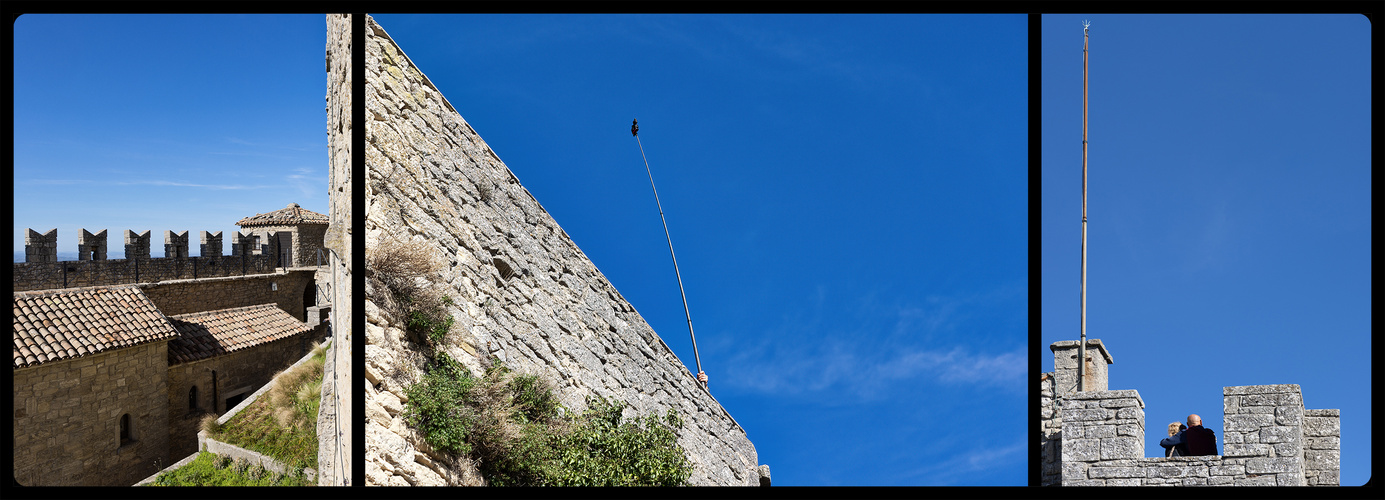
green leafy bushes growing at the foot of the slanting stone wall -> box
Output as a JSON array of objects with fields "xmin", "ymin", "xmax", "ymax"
[{"xmin": 406, "ymin": 353, "xmax": 693, "ymax": 486}]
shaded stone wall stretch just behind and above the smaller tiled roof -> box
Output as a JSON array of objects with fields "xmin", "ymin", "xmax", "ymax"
[{"xmin": 139, "ymin": 270, "xmax": 316, "ymax": 323}]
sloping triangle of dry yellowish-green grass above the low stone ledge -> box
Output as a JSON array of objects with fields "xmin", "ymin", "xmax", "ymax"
[{"xmin": 205, "ymin": 343, "xmax": 327, "ymax": 468}]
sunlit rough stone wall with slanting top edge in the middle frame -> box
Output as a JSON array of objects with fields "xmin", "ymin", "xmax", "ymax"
[{"xmin": 364, "ymin": 18, "xmax": 762, "ymax": 486}]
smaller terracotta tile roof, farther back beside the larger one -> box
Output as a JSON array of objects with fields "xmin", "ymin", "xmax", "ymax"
[{"xmin": 169, "ymin": 303, "xmax": 312, "ymax": 364}]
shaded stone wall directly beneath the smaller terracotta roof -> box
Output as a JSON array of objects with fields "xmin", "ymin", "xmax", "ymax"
[{"xmin": 168, "ymin": 325, "xmax": 327, "ymax": 460}]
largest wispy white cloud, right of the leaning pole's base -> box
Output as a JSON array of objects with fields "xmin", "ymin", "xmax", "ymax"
[{"xmin": 712, "ymin": 283, "xmax": 1028, "ymax": 400}]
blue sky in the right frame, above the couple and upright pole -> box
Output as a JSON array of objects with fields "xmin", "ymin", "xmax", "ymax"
[{"xmin": 1040, "ymin": 14, "xmax": 1371, "ymax": 485}]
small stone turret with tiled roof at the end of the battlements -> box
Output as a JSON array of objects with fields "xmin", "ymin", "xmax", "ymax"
[{"xmin": 235, "ymin": 204, "xmax": 328, "ymax": 267}]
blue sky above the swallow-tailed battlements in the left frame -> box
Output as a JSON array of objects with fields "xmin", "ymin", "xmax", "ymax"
[{"xmin": 12, "ymin": 14, "xmax": 327, "ymax": 262}]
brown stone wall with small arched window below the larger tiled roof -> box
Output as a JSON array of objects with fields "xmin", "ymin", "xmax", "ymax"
[{"xmin": 14, "ymin": 341, "xmax": 170, "ymax": 486}]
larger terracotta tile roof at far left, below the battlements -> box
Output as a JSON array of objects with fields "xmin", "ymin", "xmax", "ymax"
[{"xmin": 14, "ymin": 287, "xmax": 177, "ymax": 368}]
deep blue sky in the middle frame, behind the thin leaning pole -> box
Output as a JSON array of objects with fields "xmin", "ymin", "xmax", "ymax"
[{"xmin": 375, "ymin": 14, "xmax": 1030, "ymax": 485}]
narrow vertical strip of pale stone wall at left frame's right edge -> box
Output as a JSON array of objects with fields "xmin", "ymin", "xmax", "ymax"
[{"xmin": 317, "ymin": 14, "xmax": 360, "ymax": 486}]
